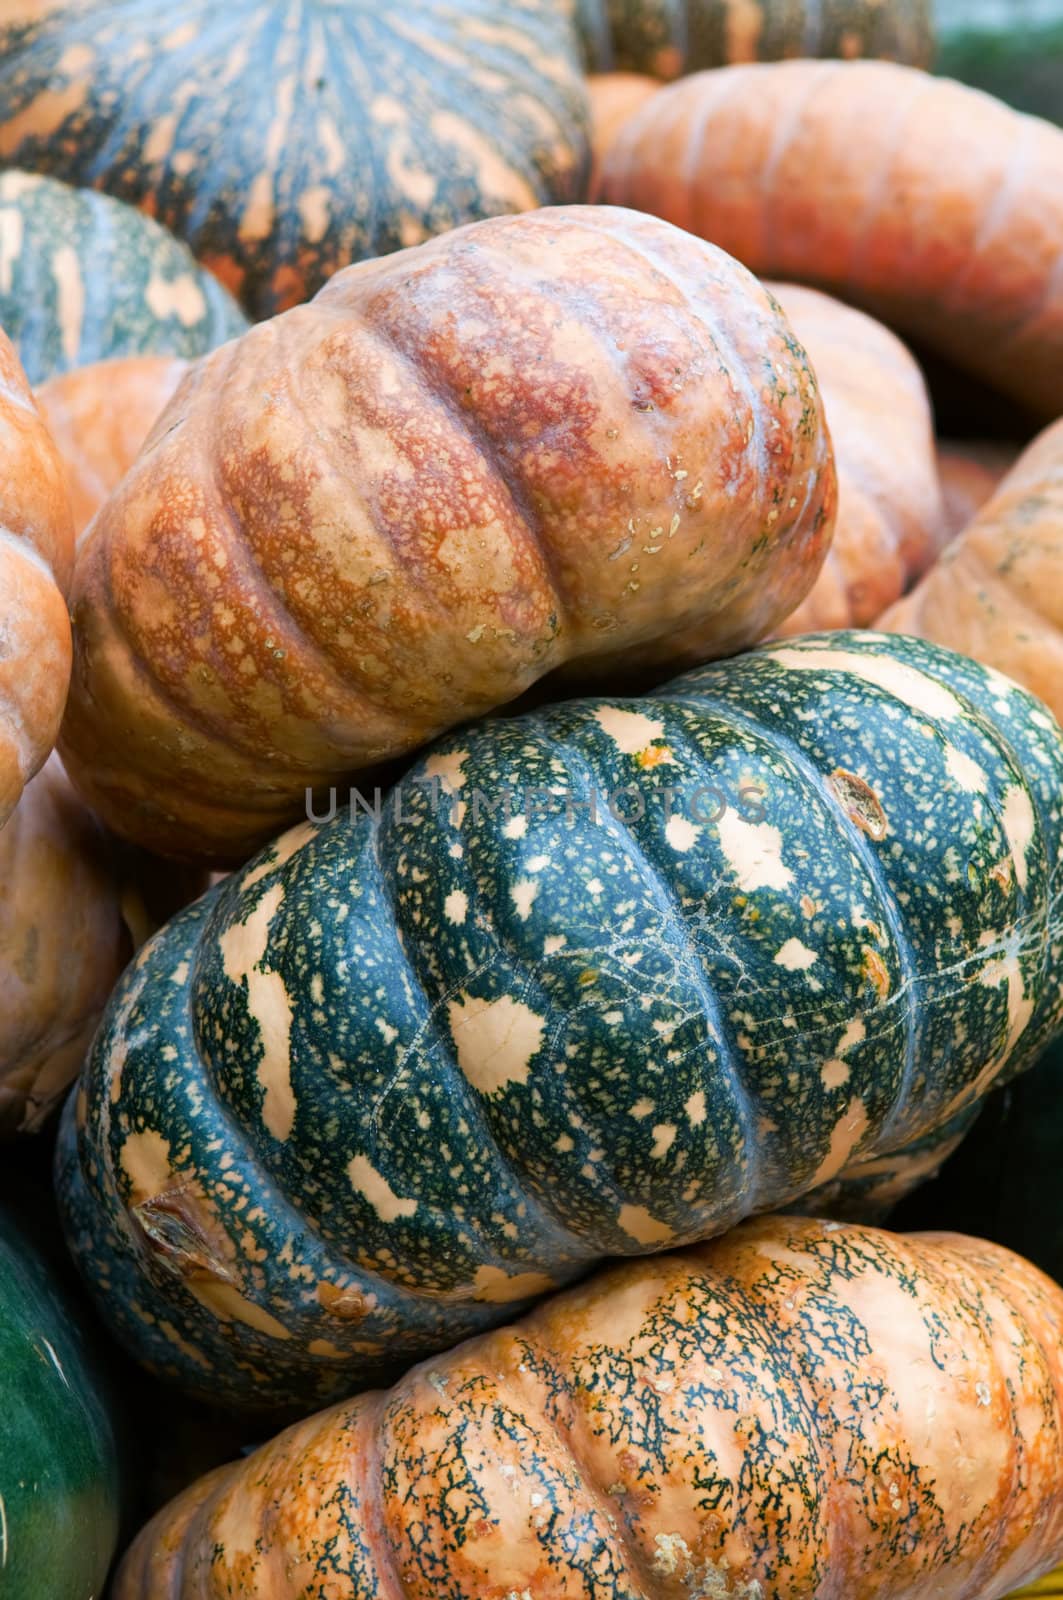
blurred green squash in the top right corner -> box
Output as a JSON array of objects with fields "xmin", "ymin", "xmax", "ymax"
[{"xmin": 933, "ymin": 0, "xmax": 1063, "ymax": 123}]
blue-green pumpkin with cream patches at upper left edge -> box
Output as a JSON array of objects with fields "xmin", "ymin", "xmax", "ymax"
[{"xmin": 0, "ymin": 173, "xmax": 247, "ymax": 384}]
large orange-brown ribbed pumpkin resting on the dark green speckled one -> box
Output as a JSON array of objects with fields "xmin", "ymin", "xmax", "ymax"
[{"xmin": 62, "ymin": 208, "xmax": 834, "ymax": 864}]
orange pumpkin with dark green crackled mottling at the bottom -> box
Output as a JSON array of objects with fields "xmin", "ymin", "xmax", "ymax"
[{"xmin": 115, "ymin": 1218, "xmax": 1063, "ymax": 1600}]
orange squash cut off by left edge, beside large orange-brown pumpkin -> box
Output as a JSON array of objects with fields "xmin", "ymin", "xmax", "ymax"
[{"xmin": 0, "ymin": 324, "xmax": 74, "ymax": 827}]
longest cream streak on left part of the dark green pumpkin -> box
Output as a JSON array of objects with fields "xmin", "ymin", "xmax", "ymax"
[{"xmin": 218, "ymin": 883, "xmax": 296, "ymax": 1141}]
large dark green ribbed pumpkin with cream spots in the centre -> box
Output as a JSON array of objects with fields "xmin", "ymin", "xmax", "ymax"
[{"xmin": 59, "ymin": 634, "xmax": 1063, "ymax": 1406}]
